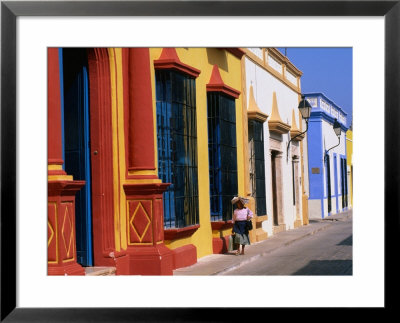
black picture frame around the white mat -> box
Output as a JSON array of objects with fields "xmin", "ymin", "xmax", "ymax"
[{"xmin": 0, "ymin": 0, "xmax": 400, "ymax": 322}]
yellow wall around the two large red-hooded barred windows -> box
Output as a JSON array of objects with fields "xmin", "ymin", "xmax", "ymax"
[{"xmin": 150, "ymin": 48, "xmax": 245, "ymax": 258}]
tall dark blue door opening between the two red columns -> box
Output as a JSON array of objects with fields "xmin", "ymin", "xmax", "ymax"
[{"xmin": 62, "ymin": 48, "xmax": 93, "ymax": 266}]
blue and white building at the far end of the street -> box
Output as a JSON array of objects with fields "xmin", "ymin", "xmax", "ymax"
[{"xmin": 305, "ymin": 93, "xmax": 349, "ymax": 219}]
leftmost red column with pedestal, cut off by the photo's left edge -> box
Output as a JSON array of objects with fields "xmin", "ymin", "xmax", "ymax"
[{"xmin": 47, "ymin": 48, "xmax": 85, "ymax": 275}]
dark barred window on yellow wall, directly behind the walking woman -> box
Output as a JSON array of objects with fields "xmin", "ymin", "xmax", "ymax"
[{"xmin": 207, "ymin": 92, "xmax": 238, "ymax": 221}]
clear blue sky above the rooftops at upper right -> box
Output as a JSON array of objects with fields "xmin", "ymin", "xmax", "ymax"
[{"xmin": 278, "ymin": 47, "xmax": 353, "ymax": 126}]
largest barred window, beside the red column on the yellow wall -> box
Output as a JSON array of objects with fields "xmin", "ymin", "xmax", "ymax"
[{"xmin": 156, "ymin": 70, "xmax": 199, "ymax": 228}]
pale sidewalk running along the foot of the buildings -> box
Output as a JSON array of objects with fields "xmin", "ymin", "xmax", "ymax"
[{"xmin": 173, "ymin": 210, "xmax": 353, "ymax": 276}]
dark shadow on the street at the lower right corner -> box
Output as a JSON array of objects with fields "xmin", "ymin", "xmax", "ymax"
[{"xmin": 293, "ymin": 260, "xmax": 353, "ymax": 276}]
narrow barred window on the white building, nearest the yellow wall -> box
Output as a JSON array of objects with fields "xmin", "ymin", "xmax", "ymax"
[{"xmin": 249, "ymin": 120, "xmax": 267, "ymax": 216}]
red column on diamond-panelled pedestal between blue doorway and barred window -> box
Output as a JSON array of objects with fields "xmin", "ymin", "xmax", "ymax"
[{"xmin": 124, "ymin": 48, "xmax": 173, "ymax": 275}]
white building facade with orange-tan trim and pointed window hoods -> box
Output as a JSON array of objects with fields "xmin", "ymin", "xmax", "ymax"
[{"xmin": 242, "ymin": 48, "xmax": 308, "ymax": 240}]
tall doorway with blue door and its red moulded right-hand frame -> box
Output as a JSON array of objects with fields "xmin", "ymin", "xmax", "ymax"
[{"xmin": 60, "ymin": 48, "xmax": 115, "ymax": 266}]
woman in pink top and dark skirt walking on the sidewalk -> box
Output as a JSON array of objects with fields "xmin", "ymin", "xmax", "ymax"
[{"xmin": 231, "ymin": 196, "xmax": 253, "ymax": 256}]
